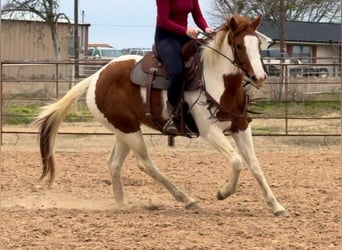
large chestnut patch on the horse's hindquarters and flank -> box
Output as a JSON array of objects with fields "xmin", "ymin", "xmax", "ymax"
[{"xmin": 95, "ymin": 60, "xmax": 166, "ymax": 133}]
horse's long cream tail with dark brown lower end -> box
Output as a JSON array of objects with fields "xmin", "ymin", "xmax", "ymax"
[{"xmin": 33, "ymin": 76, "xmax": 92, "ymax": 186}]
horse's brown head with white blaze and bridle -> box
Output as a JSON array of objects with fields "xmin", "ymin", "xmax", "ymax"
[{"xmin": 225, "ymin": 15, "xmax": 266, "ymax": 88}]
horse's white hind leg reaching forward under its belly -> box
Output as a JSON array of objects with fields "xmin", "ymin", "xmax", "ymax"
[{"xmin": 116, "ymin": 131, "xmax": 197, "ymax": 209}]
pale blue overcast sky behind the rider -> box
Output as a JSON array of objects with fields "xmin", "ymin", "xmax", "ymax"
[{"xmin": 59, "ymin": 0, "xmax": 212, "ymax": 49}]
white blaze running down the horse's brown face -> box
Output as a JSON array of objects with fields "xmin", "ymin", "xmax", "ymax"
[{"xmin": 244, "ymin": 36, "xmax": 266, "ymax": 80}]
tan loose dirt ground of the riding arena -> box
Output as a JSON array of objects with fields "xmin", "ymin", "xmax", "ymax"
[{"xmin": 0, "ymin": 130, "xmax": 342, "ymax": 249}]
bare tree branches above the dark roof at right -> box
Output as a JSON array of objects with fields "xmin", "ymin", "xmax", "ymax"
[{"xmin": 211, "ymin": 0, "xmax": 341, "ymax": 23}]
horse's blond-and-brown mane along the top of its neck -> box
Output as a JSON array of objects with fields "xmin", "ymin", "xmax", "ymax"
[{"xmin": 202, "ymin": 14, "xmax": 250, "ymax": 61}]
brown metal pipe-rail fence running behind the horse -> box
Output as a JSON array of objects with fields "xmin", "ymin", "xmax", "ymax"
[{"xmin": 0, "ymin": 60, "xmax": 341, "ymax": 140}]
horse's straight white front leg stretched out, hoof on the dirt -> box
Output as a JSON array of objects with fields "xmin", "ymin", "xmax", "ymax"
[{"xmin": 232, "ymin": 127, "xmax": 287, "ymax": 216}]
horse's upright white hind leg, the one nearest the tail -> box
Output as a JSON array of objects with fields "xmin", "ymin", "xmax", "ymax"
[{"xmin": 108, "ymin": 140, "xmax": 130, "ymax": 207}]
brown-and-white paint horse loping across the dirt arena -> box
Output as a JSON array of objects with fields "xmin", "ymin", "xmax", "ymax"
[{"xmin": 35, "ymin": 15, "xmax": 287, "ymax": 216}]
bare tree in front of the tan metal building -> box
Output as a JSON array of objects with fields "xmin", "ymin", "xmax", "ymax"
[{"xmin": 2, "ymin": 0, "xmax": 70, "ymax": 60}]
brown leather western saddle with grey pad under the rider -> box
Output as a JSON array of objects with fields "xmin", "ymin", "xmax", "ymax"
[{"xmin": 130, "ymin": 40, "xmax": 202, "ymax": 137}]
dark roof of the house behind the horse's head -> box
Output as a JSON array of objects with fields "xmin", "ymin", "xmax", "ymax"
[{"xmin": 258, "ymin": 20, "xmax": 341, "ymax": 43}]
